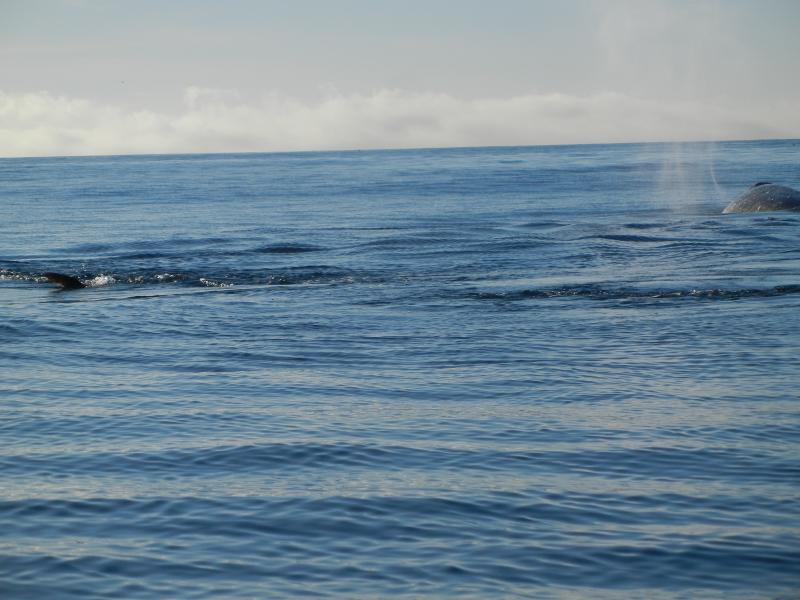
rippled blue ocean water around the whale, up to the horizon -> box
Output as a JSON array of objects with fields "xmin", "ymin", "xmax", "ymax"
[{"xmin": 0, "ymin": 140, "xmax": 800, "ymax": 599}]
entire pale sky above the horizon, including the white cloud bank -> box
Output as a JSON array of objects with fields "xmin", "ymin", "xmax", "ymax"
[{"xmin": 0, "ymin": 0, "xmax": 800, "ymax": 157}]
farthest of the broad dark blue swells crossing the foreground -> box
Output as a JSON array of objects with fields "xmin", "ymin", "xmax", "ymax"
[{"xmin": 0, "ymin": 443, "xmax": 800, "ymax": 484}]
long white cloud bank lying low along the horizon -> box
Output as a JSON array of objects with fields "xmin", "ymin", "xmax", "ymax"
[{"xmin": 0, "ymin": 87, "xmax": 800, "ymax": 157}]
